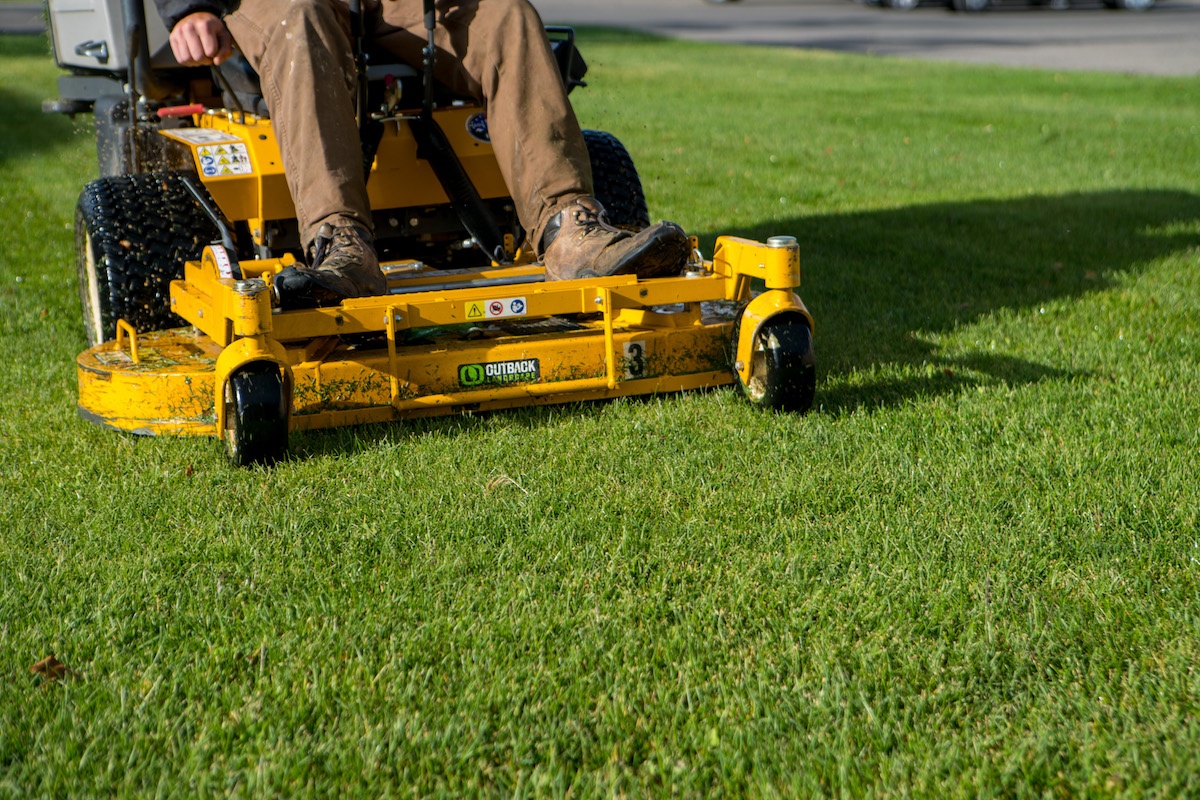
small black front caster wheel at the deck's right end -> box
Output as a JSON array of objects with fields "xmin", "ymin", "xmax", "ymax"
[{"xmin": 734, "ymin": 314, "xmax": 817, "ymax": 413}]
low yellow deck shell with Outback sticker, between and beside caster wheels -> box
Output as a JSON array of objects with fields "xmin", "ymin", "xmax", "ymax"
[{"xmin": 78, "ymin": 323, "xmax": 734, "ymax": 435}]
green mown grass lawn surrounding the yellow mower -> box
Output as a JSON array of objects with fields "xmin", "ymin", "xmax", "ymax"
[{"xmin": 0, "ymin": 30, "xmax": 1200, "ymax": 798}]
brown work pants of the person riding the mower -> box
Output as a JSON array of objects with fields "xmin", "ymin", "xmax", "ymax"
[{"xmin": 226, "ymin": 0, "xmax": 592, "ymax": 246}]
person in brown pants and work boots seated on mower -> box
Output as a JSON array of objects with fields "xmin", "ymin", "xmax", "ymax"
[{"xmin": 156, "ymin": 0, "xmax": 690, "ymax": 308}]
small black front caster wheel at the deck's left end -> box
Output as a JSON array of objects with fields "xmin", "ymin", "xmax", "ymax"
[{"xmin": 224, "ymin": 361, "xmax": 288, "ymax": 467}]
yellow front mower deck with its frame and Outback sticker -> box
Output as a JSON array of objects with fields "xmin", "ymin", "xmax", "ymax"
[{"xmin": 78, "ymin": 237, "xmax": 812, "ymax": 461}]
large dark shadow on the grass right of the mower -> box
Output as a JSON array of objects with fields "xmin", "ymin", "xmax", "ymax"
[{"xmin": 720, "ymin": 190, "xmax": 1200, "ymax": 414}]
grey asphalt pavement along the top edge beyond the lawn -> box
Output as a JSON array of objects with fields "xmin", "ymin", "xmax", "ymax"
[{"xmin": 9, "ymin": 0, "xmax": 1200, "ymax": 76}]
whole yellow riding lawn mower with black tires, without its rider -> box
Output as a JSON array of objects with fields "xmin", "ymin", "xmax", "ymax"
[{"xmin": 46, "ymin": 0, "xmax": 816, "ymax": 465}]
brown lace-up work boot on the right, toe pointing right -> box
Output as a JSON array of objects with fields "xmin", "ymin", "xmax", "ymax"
[{"xmin": 541, "ymin": 197, "xmax": 691, "ymax": 281}]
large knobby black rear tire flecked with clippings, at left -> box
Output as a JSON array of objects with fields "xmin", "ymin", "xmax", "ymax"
[{"xmin": 76, "ymin": 173, "xmax": 217, "ymax": 345}]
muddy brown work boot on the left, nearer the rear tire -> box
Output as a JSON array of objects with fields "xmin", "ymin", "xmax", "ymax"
[{"xmin": 271, "ymin": 218, "xmax": 388, "ymax": 311}]
